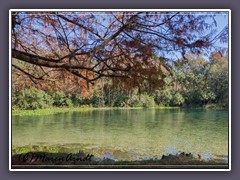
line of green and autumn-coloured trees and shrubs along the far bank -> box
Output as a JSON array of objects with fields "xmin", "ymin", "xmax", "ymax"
[{"xmin": 12, "ymin": 52, "xmax": 228, "ymax": 109}]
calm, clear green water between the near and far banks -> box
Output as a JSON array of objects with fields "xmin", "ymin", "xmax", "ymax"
[{"xmin": 12, "ymin": 109, "xmax": 228, "ymax": 160}]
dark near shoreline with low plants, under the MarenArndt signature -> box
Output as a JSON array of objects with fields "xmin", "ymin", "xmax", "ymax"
[{"xmin": 11, "ymin": 146, "xmax": 228, "ymax": 168}]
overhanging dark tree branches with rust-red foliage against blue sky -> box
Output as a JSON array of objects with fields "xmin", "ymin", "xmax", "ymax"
[{"xmin": 12, "ymin": 12, "xmax": 227, "ymax": 91}]
